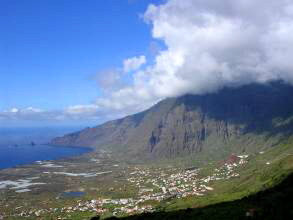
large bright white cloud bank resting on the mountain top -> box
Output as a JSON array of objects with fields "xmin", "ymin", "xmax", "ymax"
[{"xmin": 3, "ymin": 0, "xmax": 293, "ymax": 124}]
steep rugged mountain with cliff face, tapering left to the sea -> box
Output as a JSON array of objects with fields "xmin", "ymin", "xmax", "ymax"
[{"xmin": 52, "ymin": 82, "xmax": 293, "ymax": 159}]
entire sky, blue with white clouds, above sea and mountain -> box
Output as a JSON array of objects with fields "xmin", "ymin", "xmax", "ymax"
[{"xmin": 0, "ymin": 0, "xmax": 293, "ymax": 126}]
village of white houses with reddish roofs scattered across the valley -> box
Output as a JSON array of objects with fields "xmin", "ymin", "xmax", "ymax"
[{"xmin": 8, "ymin": 155, "xmax": 248, "ymax": 219}]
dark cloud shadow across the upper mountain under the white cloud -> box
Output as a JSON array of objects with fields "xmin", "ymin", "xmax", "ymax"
[{"xmin": 176, "ymin": 81, "xmax": 293, "ymax": 135}]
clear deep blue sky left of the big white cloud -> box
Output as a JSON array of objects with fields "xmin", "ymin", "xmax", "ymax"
[{"xmin": 0, "ymin": 0, "xmax": 160, "ymax": 110}]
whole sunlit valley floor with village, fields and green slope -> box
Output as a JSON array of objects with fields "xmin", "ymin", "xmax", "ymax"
[{"xmin": 0, "ymin": 144, "xmax": 293, "ymax": 219}]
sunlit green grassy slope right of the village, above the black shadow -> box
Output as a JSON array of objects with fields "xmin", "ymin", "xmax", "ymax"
[{"xmin": 164, "ymin": 139, "xmax": 293, "ymax": 211}]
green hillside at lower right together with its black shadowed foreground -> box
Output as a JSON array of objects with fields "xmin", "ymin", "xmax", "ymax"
[{"xmin": 99, "ymin": 143, "xmax": 293, "ymax": 220}]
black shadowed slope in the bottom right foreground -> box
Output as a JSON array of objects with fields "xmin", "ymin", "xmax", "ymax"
[{"xmin": 92, "ymin": 173, "xmax": 293, "ymax": 220}]
